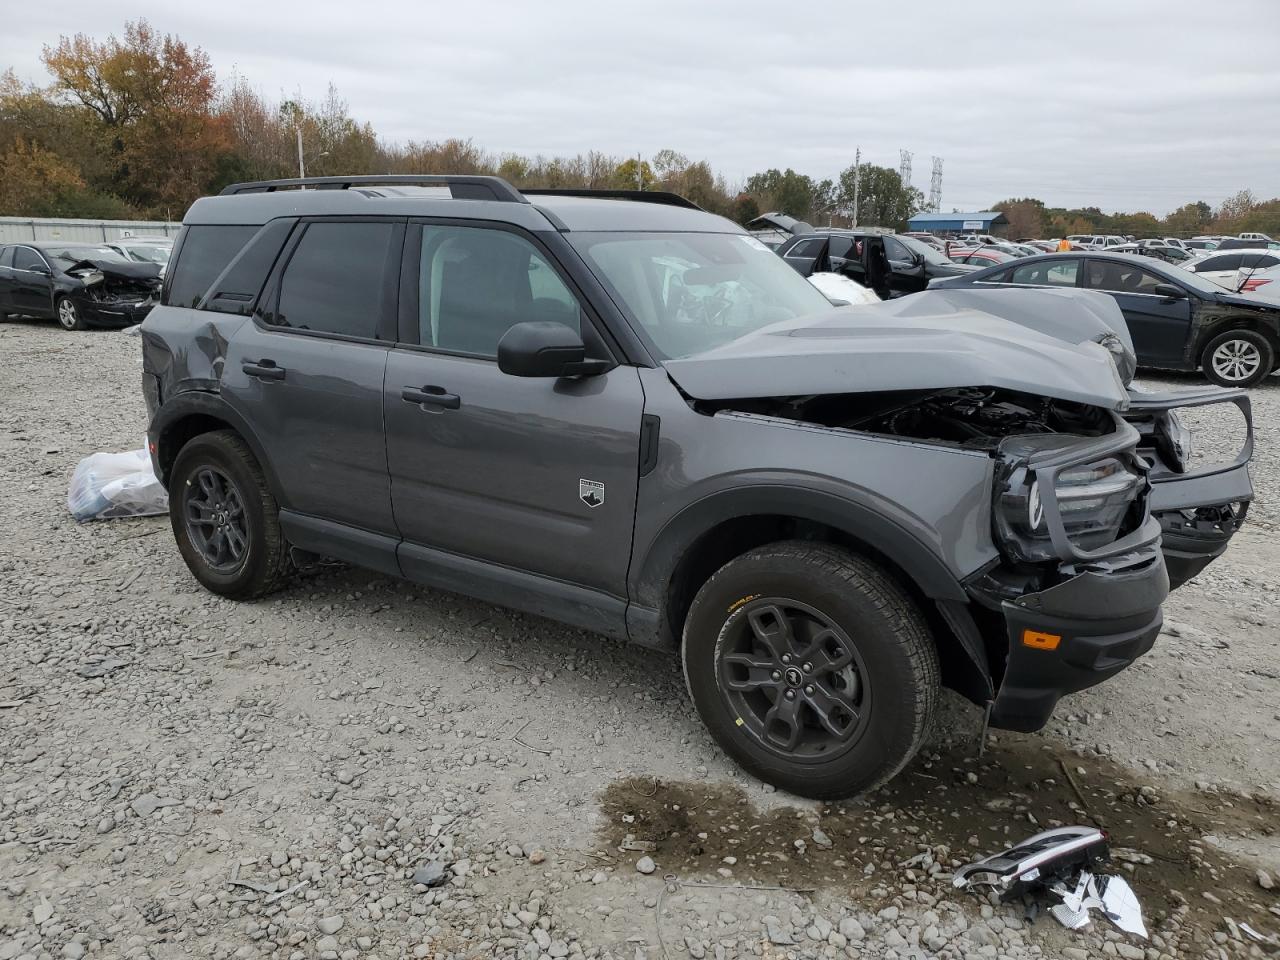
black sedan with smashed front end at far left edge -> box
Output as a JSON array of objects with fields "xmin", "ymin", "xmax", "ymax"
[{"xmin": 0, "ymin": 241, "xmax": 160, "ymax": 330}]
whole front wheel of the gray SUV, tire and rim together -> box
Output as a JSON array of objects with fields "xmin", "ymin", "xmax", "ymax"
[{"xmin": 682, "ymin": 540, "xmax": 940, "ymax": 800}]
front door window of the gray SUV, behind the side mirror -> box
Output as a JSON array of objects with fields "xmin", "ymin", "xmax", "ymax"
[{"xmin": 417, "ymin": 224, "xmax": 582, "ymax": 360}]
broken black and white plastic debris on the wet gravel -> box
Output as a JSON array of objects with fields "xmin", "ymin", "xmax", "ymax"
[{"xmin": 951, "ymin": 827, "xmax": 1147, "ymax": 940}]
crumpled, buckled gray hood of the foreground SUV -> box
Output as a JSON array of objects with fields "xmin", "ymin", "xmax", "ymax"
[{"xmin": 664, "ymin": 291, "xmax": 1129, "ymax": 411}]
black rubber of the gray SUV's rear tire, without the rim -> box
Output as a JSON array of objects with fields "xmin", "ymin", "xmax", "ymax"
[{"xmin": 169, "ymin": 435, "xmax": 269, "ymax": 596}]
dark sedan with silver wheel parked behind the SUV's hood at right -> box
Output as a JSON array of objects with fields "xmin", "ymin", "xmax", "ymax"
[{"xmin": 931, "ymin": 251, "xmax": 1280, "ymax": 387}]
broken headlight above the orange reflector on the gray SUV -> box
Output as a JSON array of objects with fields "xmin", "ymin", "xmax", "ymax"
[{"xmin": 996, "ymin": 457, "xmax": 1144, "ymax": 561}]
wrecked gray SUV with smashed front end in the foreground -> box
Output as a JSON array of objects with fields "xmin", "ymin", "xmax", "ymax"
[{"xmin": 142, "ymin": 177, "xmax": 1252, "ymax": 797}]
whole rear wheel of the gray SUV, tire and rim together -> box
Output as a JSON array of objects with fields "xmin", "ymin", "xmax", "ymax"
[{"xmin": 169, "ymin": 430, "xmax": 289, "ymax": 600}]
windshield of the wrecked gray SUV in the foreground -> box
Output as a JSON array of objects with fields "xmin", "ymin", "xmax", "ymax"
[{"xmin": 566, "ymin": 233, "xmax": 831, "ymax": 360}]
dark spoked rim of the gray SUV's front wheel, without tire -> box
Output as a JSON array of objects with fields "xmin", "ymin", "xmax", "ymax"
[{"xmin": 716, "ymin": 596, "xmax": 872, "ymax": 760}]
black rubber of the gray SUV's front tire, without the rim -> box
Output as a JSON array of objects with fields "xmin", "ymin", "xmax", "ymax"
[{"xmin": 682, "ymin": 556, "xmax": 925, "ymax": 797}]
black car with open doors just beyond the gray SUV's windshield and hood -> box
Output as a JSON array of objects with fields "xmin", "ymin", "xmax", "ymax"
[{"xmin": 776, "ymin": 229, "xmax": 975, "ymax": 300}]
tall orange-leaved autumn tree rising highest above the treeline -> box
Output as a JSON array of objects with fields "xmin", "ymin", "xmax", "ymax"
[{"xmin": 42, "ymin": 20, "xmax": 229, "ymax": 215}]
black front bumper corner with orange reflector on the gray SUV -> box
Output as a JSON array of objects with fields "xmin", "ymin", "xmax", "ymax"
[{"xmin": 991, "ymin": 550, "xmax": 1169, "ymax": 732}]
